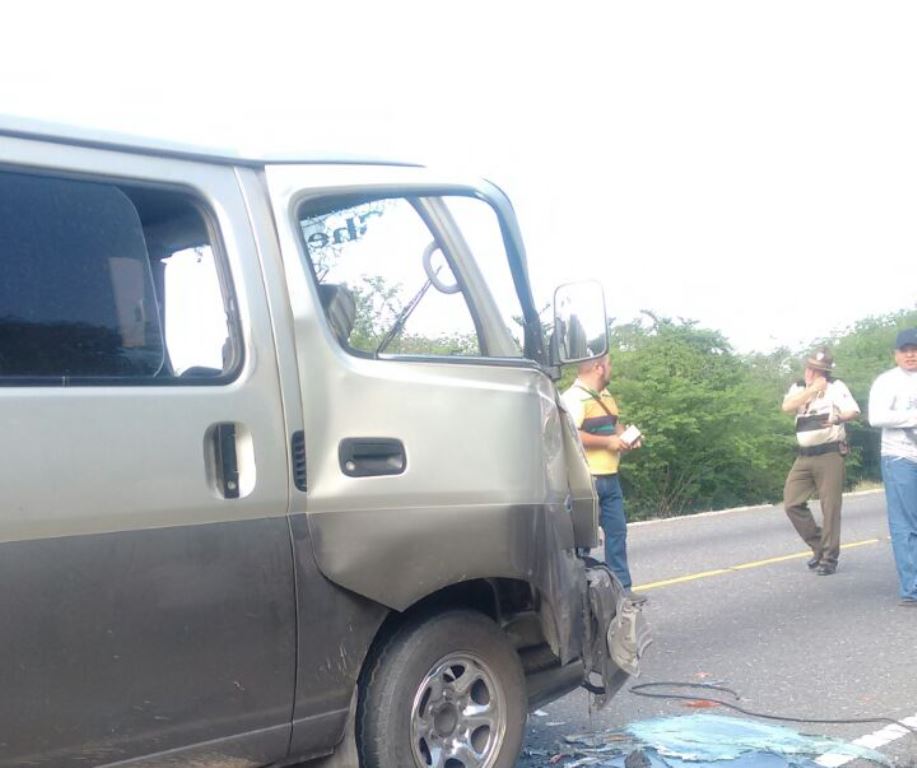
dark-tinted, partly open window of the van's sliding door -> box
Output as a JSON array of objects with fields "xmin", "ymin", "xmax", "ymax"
[{"xmin": 0, "ymin": 171, "xmax": 238, "ymax": 386}]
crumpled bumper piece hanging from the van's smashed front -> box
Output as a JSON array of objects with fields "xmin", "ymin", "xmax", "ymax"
[{"xmin": 584, "ymin": 563, "xmax": 653, "ymax": 709}]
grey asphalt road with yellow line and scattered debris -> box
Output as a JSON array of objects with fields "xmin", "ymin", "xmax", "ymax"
[{"xmin": 519, "ymin": 492, "xmax": 917, "ymax": 768}]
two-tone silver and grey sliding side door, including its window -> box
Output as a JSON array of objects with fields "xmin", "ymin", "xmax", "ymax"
[{"xmin": 0, "ymin": 146, "xmax": 295, "ymax": 768}]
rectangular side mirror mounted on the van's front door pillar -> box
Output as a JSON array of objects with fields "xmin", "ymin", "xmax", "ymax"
[{"xmin": 551, "ymin": 280, "xmax": 608, "ymax": 365}]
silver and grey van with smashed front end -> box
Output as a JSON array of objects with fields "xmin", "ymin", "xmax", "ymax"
[{"xmin": 0, "ymin": 119, "xmax": 648, "ymax": 768}]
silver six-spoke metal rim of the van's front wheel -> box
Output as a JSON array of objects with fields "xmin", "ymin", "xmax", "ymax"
[{"xmin": 411, "ymin": 653, "xmax": 506, "ymax": 768}]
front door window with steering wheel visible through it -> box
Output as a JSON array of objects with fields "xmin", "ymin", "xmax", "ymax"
[{"xmin": 299, "ymin": 197, "xmax": 521, "ymax": 357}]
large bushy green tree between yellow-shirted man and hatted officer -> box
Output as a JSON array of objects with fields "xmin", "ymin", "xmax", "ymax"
[{"xmin": 611, "ymin": 319, "xmax": 790, "ymax": 516}]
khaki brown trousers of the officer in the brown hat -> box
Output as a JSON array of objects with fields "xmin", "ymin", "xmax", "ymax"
[{"xmin": 783, "ymin": 452, "xmax": 844, "ymax": 565}]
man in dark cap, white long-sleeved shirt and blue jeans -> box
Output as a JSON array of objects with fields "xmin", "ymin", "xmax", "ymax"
[{"xmin": 869, "ymin": 328, "xmax": 917, "ymax": 608}]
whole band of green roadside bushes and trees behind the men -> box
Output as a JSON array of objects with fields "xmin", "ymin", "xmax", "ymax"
[{"xmin": 561, "ymin": 308, "xmax": 917, "ymax": 520}]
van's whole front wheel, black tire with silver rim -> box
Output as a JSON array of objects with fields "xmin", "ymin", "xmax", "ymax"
[{"xmin": 357, "ymin": 611, "xmax": 527, "ymax": 768}]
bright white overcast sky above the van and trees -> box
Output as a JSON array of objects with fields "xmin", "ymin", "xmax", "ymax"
[{"xmin": 0, "ymin": 0, "xmax": 917, "ymax": 352}]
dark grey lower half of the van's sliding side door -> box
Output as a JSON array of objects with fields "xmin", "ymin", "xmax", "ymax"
[{"xmin": 0, "ymin": 517, "xmax": 295, "ymax": 768}]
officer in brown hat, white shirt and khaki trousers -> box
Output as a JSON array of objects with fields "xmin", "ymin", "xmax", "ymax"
[{"xmin": 783, "ymin": 349, "xmax": 860, "ymax": 576}]
